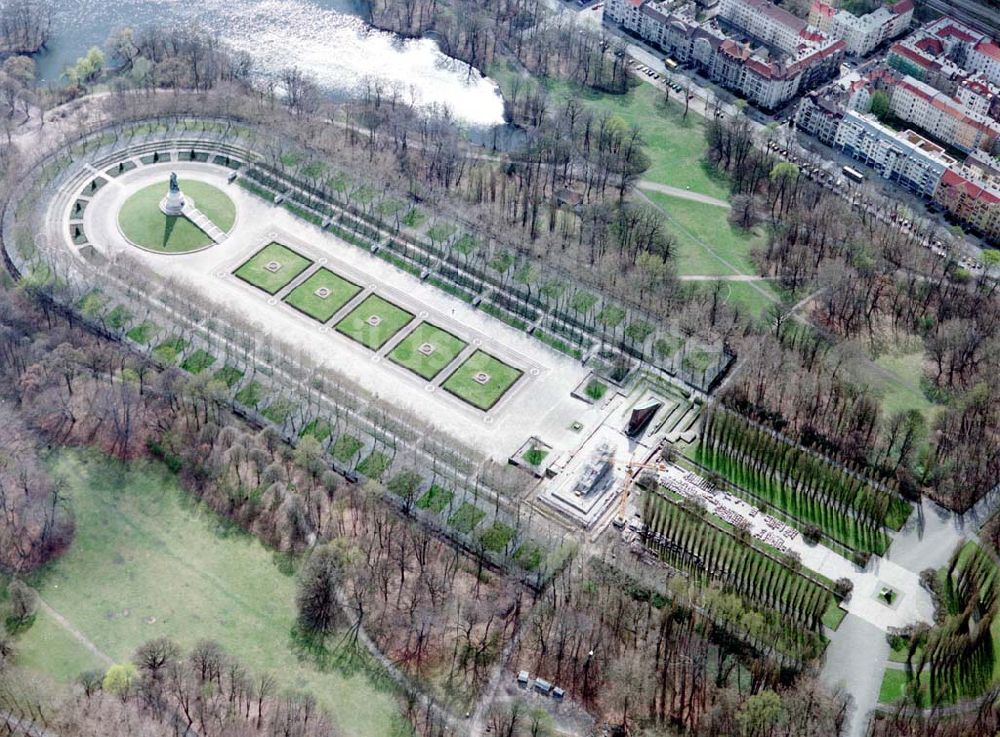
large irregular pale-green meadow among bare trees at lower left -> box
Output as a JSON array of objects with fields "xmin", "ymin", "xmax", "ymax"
[{"xmin": 19, "ymin": 451, "xmax": 405, "ymax": 737}]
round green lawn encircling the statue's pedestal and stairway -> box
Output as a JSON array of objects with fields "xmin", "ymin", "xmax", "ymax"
[{"xmin": 118, "ymin": 180, "xmax": 236, "ymax": 253}]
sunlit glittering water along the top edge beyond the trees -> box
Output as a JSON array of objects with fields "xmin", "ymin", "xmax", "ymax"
[{"xmin": 38, "ymin": 0, "xmax": 503, "ymax": 126}]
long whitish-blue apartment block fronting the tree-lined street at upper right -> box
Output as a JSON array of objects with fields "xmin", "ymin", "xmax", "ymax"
[{"xmin": 834, "ymin": 110, "xmax": 957, "ymax": 197}]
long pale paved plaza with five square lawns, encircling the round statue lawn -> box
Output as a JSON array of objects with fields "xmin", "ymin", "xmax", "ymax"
[{"xmin": 74, "ymin": 161, "xmax": 604, "ymax": 462}]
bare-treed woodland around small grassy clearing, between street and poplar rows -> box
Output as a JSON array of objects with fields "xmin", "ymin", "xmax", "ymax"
[{"xmin": 708, "ymin": 116, "xmax": 1000, "ymax": 509}]
